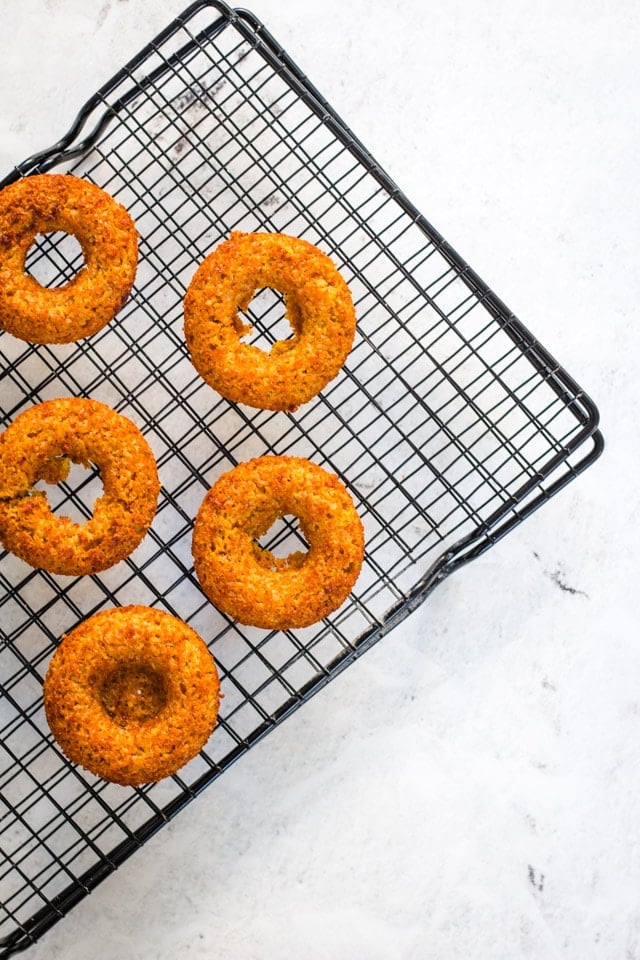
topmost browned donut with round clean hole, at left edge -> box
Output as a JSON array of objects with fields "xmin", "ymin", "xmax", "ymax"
[{"xmin": 0, "ymin": 173, "xmax": 138, "ymax": 343}]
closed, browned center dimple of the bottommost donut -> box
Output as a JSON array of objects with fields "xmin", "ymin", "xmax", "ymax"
[{"xmin": 99, "ymin": 663, "xmax": 167, "ymax": 727}]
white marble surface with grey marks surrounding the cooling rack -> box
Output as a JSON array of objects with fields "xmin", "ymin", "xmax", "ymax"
[{"xmin": 0, "ymin": 0, "xmax": 640, "ymax": 960}]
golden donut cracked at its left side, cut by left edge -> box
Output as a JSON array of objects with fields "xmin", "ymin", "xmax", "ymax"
[{"xmin": 0, "ymin": 397, "xmax": 160, "ymax": 576}]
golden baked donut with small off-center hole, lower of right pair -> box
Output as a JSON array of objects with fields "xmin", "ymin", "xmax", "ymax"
[{"xmin": 192, "ymin": 456, "xmax": 364, "ymax": 630}]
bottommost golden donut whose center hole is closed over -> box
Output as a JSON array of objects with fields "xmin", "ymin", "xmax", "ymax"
[{"xmin": 43, "ymin": 605, "xmax": 220, "ymax": 786}]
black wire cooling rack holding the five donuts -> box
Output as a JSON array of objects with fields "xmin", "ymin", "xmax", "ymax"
[{"xmin": 0, "ymin": 0, "xmax": 602, "ymax": 957}]
